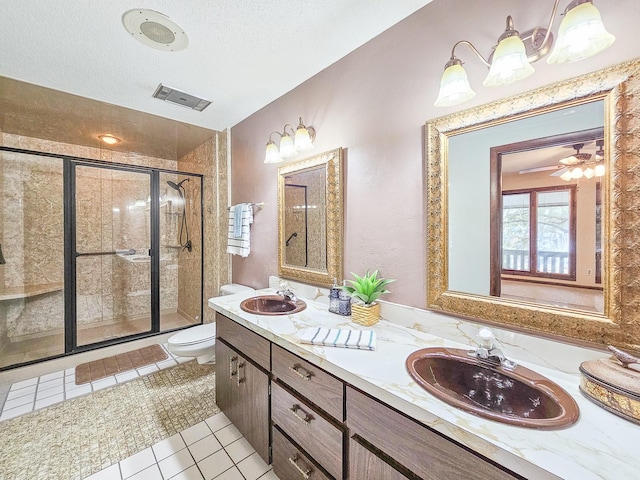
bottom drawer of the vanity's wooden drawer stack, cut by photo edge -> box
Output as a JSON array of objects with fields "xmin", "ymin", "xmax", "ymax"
[{"xmin": 272, "ymin": 428, "xmax": 329, "ymax": 480}]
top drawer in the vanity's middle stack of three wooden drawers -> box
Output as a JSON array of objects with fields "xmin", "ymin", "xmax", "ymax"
[{"xmin": 272, "ymin": 345, "xmax": 344, "ymax": 421}]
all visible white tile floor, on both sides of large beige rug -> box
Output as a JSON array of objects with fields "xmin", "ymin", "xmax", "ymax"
[{"xmin": 0, "ymin": 345, "xmax": 278, "ymax": 480}]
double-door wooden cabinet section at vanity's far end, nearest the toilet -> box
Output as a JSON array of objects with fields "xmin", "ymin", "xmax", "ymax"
[{"xmin": 216, "ymin": 314, "xmax": 270, "ymax": 463}]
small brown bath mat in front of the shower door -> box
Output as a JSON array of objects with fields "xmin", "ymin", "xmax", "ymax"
[{"xmin": 76, "ymin": 343, "xmax": 168, "ymax": 385}]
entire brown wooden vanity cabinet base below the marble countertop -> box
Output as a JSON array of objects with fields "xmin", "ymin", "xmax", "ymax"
[{"xmin": 216, "ymin": 313, "xmax": 523, "ymax": 480}]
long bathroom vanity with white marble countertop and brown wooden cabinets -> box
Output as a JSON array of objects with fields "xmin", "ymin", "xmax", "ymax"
[{"xmin": 209, "ymin": 289, "xmax": 640, "ymax": 480}]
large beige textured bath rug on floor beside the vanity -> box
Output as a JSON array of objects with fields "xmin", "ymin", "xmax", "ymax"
[{"xmin": 0, "ymin": 361, "xmax": 220, "ymax": 480}]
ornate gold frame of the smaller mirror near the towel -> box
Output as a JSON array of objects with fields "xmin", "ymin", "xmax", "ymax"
[{"xmin": 278, "ymin": 148, "xmax": 344, "ymax": 287}]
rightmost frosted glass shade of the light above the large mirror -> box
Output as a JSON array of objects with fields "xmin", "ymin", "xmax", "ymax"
[{"xmin": 547, "ymin": 2, "xmax": 616, "ymax": 63}]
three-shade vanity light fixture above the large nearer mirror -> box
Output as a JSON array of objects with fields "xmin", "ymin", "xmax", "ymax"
[{"xmin": 434, "ymin": 0, "xmax": 615, "ymax": 107}]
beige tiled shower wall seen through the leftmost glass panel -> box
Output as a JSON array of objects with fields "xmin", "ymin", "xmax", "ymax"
[{"xmin": 0, "ymin": 148, "xmax": 64, "ymax": 339}]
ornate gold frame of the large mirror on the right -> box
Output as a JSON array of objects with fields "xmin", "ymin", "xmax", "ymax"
[{"xmin": 424, "ymin": 59, "xmax": 640, "ymax": 352}]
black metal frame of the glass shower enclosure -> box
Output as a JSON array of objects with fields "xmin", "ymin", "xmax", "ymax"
[{"xmin": 0, "ymin": 145, "xmax": 206, "ymax": 371}]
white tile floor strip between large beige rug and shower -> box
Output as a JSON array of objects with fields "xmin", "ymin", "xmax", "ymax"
[{"xmin": 0, "ymin": 346, "xmax": 190, "ymax": 421}]
